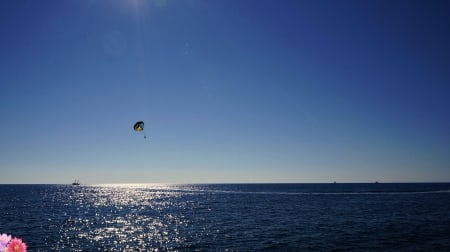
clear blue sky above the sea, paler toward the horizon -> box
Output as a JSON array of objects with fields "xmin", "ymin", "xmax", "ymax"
[{"xmin": 0, "ymin": 0, "xmax": 450, "ymax": 184}]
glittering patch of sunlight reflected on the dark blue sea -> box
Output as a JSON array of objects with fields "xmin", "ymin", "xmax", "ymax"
[{"xmin": 54, "ymin": 184, "xmax": 203, "ymax": 251}]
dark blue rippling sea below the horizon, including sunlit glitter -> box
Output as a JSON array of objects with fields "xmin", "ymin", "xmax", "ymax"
[{"xmin": 0, "ymin": 183, "xmax": 450, "ymax": 251}]
